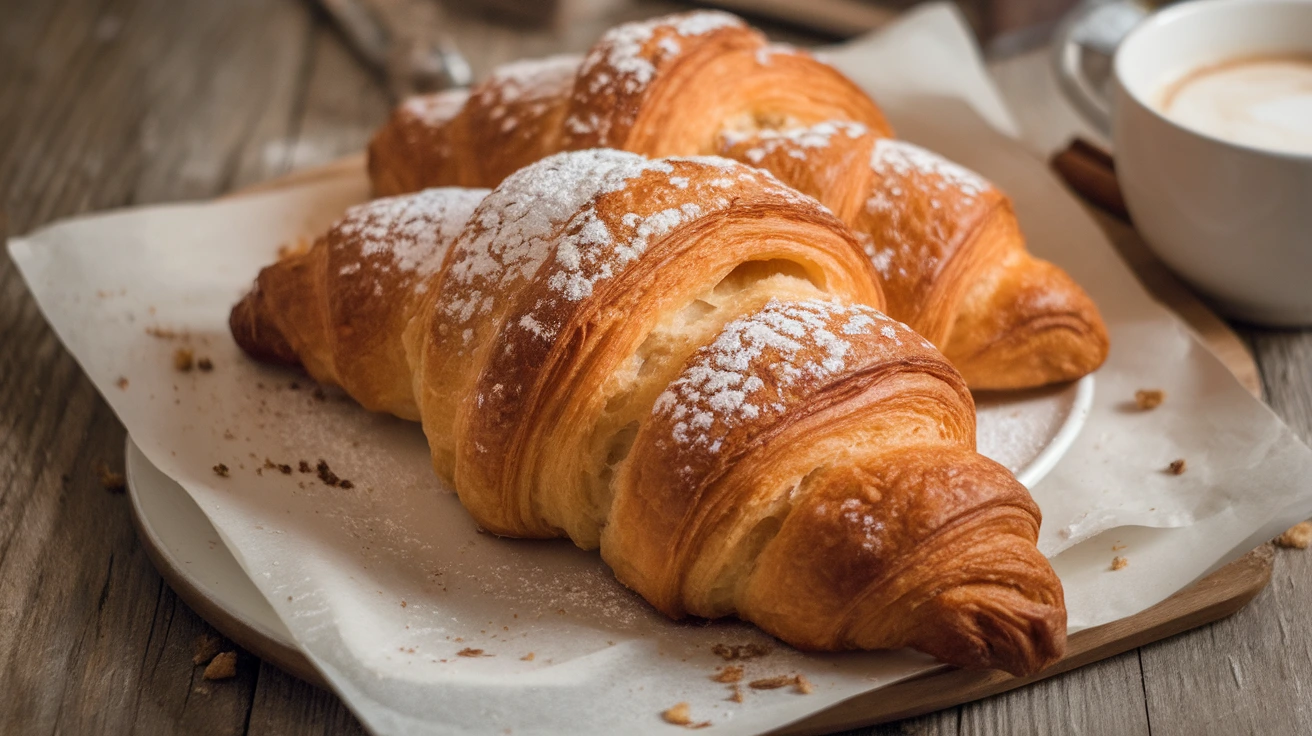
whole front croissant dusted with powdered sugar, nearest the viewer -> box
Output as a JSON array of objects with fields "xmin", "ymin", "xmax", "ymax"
[{"xmin": 231, "ymin": 150, "xmax": 1065, "ymax": 673}]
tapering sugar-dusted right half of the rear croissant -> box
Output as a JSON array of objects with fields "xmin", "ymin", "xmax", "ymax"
[{"xmin": 720, "ymin": 122, "xmax": 1109, "ymax": 388}]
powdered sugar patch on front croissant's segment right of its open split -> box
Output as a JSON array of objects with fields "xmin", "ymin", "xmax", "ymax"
[{"xmin": 652, "ymin": 299, "xmax": 913, "ymax": 453}]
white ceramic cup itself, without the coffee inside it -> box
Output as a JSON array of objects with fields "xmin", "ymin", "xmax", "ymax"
[{"xmin": 1068, "ymin": 0, "xmax": 1312, "ymax": 325}]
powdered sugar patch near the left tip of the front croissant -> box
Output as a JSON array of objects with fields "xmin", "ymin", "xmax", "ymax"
[{"xmin": 333, "ymin": 186, "xmax": 488, "ymax": 287}]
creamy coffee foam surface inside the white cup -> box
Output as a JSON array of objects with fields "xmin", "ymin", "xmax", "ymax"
[{"xmin": 1157, "ymin": 55, "xmax": 1312, "ymax": 153}]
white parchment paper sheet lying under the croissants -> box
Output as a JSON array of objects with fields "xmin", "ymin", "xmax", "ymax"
[{"xmin": 9, "ymin": 7, "xmax": 1312, "ymax": 733}]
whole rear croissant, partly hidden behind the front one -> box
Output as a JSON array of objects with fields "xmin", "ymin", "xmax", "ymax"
[{"xmin": 369, "ymin": 12, "xmax": 1109, "ymax": 388}]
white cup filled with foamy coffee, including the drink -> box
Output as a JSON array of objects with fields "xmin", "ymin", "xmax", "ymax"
[{"xmin": 1059, "ymin": 0, "xmax": 1312, "ymax": 325}]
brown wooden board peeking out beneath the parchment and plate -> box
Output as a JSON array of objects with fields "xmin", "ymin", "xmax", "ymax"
[{"xmin": 174, "ymin": 155, "xmax": 1274, "ymax": 735}]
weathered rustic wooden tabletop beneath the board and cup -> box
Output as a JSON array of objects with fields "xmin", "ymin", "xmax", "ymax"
[{"xmin": 0, "ymin": 0, "xmax": 1312, "ymax": 735}]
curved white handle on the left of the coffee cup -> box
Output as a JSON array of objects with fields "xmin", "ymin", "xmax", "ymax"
[{"xmin": 1052, "ymin": 0, "xmax": 1147, "ymax": 138}]
